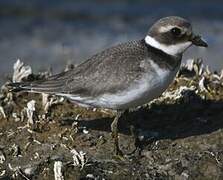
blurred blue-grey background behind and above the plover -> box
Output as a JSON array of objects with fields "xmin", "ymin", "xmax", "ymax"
[{"xmin": 0, "ymin": 0, "xmax": 223, "ymax": 82}]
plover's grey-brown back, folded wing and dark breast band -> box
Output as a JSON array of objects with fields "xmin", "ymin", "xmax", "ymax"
[{"xmin": 11, "ymin": 40, "xmax": 181, "ymax": 100}]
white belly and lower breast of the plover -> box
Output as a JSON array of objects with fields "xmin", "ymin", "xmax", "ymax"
[{"xmin": 71, "ymin": 62, "xmax": 179, "ymax": 109}]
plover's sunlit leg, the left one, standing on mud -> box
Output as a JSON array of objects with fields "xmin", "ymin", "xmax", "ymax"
[{"xmin": 111, "ymin": 111, "xmax": 123, "ymax": 156}]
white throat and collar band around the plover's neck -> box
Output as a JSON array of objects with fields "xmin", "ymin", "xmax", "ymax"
[{"xmin": 145, "ymin": 35, "xmax": 192, "ymax": 56}]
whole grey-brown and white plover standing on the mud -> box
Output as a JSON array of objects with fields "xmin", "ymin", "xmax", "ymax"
[{"xmin": 9, "ymin": 16, "xmax": 207, "ymax": 153}]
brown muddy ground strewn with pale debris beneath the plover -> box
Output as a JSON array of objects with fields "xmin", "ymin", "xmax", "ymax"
[{"xmin": 0, "ymin": 59, "xmax": 223, "ymax": 180}]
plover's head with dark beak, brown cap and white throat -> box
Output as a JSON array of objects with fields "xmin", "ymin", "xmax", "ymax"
[{"xmin": 145, "ymin": 16, "xmax": 208, "ymax": 56}]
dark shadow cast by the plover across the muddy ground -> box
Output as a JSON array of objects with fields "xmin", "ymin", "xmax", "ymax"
[{"xmin": 66, "ymin": 94, "xmax": 223, "ymax": 140}]
